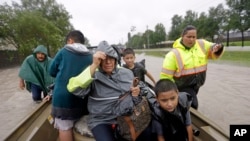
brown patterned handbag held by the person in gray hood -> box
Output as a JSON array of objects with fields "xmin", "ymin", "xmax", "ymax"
[{"xmin": 114, "ymin": 79, "xmax": 151, "ymax": 141}]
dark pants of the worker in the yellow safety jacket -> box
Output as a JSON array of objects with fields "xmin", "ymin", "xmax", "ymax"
[{"xmin": 179, "ymin": 88, "xmax": 199, "ymax": 110}]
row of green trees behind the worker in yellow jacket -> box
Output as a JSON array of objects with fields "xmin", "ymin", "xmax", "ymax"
[{"xmin": 127, "ymin": 0, "xmax": 250, "ymax": 48}]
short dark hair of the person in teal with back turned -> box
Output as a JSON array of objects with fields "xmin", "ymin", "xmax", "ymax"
[{"xmin": 66, "ymin": 30, "xmax": 85, "ymax": 44}]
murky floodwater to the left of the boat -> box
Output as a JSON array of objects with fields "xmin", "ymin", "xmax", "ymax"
[{"xmin": 0, "ymin": 67, "xmax": 37, "ymax": 141}]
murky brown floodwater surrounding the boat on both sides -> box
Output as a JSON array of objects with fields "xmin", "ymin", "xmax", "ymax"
[{"xmin": 0, "ymin": 51, "xmax": 250, "ymax": 140}]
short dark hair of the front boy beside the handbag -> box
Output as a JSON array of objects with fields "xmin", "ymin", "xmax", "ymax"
[{"xmin": 154, "ymin": 79, "xmax": 178, "ymax": 96}]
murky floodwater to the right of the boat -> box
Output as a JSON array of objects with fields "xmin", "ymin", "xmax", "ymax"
[{"xmin": 140, "ymin": 53, "xmax": 250, "ymax": 135}]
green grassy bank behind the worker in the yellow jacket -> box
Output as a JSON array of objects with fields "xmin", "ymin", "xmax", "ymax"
[{"xmin": 136, "ymin": 50, "xmax": 250, "ymax": 67}]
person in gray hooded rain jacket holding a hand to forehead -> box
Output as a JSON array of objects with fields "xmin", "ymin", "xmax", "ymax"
[{"xmin": 67, "ymin": 41, "xmax": 144, "ymax": 141}]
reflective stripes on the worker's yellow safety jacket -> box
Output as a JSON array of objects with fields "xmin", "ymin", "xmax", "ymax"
[{"xmin": 162, "ymin": 40, "xmax": 207, "ymax": 77}]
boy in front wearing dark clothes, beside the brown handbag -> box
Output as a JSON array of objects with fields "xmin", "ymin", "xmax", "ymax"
[{"xmin": 152, "ymin": 79, "xmax": 193, "ymax": 141}]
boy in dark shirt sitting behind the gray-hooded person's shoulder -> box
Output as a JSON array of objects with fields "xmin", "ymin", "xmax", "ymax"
[{"xmin": 122, "ymin": 48, "xmax": 155, "ymax": 85}]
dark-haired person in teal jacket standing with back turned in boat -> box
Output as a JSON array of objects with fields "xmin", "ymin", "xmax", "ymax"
[{"xmin": 49, "ymin": 30, "xmax": 92, "ymax": 141}]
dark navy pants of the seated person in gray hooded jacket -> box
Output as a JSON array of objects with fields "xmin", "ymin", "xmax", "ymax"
[{"xmin": 92, "ymin": 124, "xmax": 115, "ymax": 141}]
